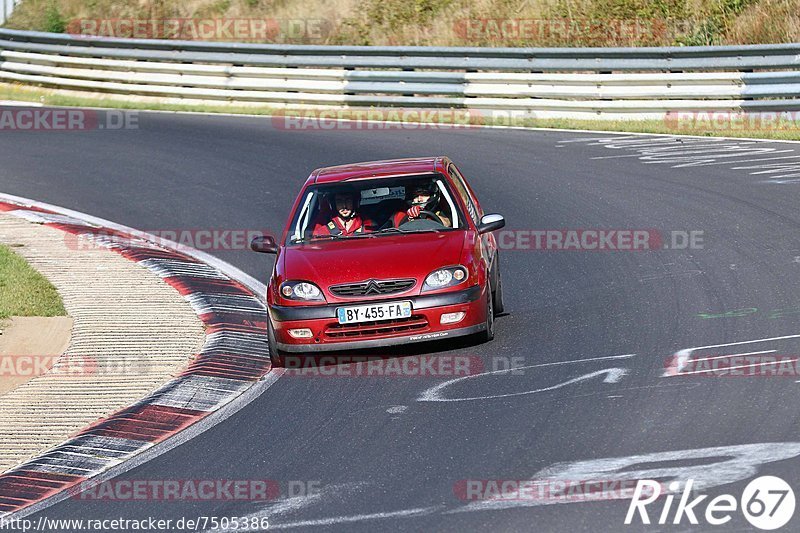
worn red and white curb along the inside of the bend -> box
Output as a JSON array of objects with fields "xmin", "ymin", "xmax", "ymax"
[{"xmin": 0, "ymin": 194, "xmax": 271, "ymax": 517}]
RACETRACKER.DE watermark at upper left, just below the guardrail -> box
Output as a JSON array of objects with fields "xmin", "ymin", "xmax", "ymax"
[{"xmin": 0, "ymin": 107, "xmax": 139, "ymax": 132}]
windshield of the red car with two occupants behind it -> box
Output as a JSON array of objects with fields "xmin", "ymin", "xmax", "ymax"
[{"xmin": 286, "ymin": 174, "xmax": 465, "ymax": 246}]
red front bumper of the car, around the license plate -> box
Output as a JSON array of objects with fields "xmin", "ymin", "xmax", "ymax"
[{"xmin": 269, "ymin": 285, "xmax": 486, "ymax": 353}]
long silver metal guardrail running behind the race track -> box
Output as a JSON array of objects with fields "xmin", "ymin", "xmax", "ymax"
[{"xmin": 0, "ymin": 27, "xmax": 800, "ymax": 118}]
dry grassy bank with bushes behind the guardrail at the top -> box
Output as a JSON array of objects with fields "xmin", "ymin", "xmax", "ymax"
[{"xmin": 7, "ymin": 0, "xmax": 800, "ymax": 46}]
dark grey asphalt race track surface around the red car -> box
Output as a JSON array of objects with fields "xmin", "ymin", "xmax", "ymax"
[{"xmin": 0, "ymin": 107, "xmax": 800, "ymax": 532}]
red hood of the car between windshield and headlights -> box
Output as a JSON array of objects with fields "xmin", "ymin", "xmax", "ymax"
[{"xmin": 283, "ymin": 231, "xmax": 466, "ymax": 292}]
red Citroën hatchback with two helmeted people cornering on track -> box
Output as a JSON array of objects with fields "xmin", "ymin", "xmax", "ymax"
[{"xmin": 251, "ymin": 157, "xmax": 505, "ymax": 363}]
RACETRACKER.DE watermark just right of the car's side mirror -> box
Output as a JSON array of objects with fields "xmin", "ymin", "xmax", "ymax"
[{"xmin": 496, "ymin": 228, "xmax": 705, "ymax": 252}]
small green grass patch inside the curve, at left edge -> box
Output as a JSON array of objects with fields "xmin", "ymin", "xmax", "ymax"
[{"xmin": 0, "ymin": 244, "xmax": 67, "ymax": 320}]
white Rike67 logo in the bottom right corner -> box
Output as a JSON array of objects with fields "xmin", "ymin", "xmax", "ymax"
[{"xmin": 625, "ymin": 476, "xmax": 795, "ymax": 530}]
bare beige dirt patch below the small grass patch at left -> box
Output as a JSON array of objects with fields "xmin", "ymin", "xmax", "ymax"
[{"xmin": 0, "ymin": 316, "xmax": 72, "ymax": 396}]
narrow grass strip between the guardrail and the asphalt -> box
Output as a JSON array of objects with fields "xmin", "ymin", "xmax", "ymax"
[{"xmin": 0, "ymin": 83, "xmax": 800, "ymax": 141}]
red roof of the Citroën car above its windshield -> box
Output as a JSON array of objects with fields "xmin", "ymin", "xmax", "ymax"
[{"xmin": 306, "ymin": 156, "xmax": 447, "ymax": 185}]
